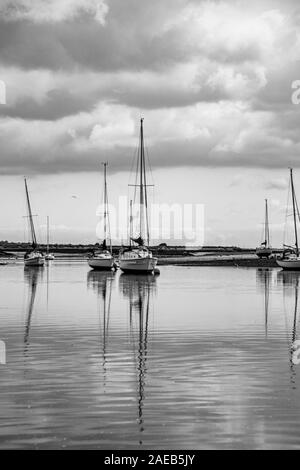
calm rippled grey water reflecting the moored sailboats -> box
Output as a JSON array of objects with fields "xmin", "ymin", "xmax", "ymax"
[{"xmin": 0, "ymin": 261, "xmax": 300, "ymax": 449}]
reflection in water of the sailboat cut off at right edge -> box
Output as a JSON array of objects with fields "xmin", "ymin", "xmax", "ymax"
[{"xmin": 277, "ymin": 271, "xmax": 300, "ymax": 382}]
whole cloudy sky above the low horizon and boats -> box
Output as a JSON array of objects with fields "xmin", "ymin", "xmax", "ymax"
[{"xmin": 0, "ymin": 0, "xmax": 300, "ymax": 247}]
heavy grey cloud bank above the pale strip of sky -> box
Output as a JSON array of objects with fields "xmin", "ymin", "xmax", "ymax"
[{"xmin": 0, "ymin": 0, "xmax": 300, "ymax": 173}]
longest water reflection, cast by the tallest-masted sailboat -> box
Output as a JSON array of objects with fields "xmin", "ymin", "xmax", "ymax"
[{"xmin": 119, "ymin": 274, "xmax": 156, "ymax": 445}]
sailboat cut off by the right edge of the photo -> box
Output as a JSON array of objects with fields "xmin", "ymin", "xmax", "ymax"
[{"xmin": 276, "ymin": 168, "xmax": 300, "ymax": 271}]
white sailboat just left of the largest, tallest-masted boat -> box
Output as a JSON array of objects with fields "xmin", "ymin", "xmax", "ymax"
[{"xmin": 88, "ymin": 162, "xmax": 115, "ymax": 270}]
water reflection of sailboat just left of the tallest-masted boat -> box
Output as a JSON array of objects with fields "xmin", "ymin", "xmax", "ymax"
[{"xmin": 87, "ymin": 270, "xmax": 115, "ymax": 386}]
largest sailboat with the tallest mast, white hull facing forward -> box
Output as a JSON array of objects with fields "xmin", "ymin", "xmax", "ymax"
[{"xmin": 119, "ymin": 118, "xmax": 157, "ymax": 273}]
